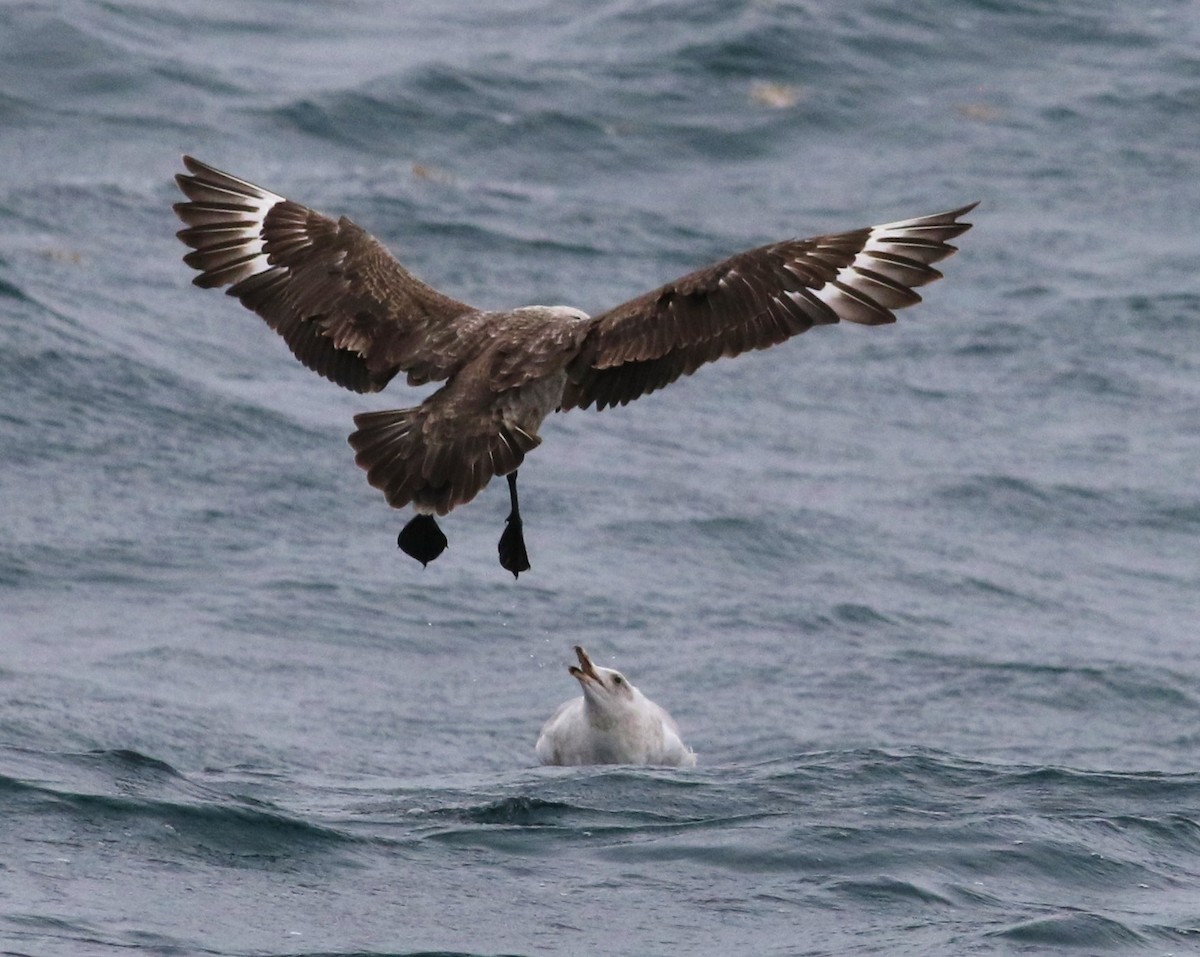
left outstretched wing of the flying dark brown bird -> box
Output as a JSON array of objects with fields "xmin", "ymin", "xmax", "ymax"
[{"xmin": 174, "ymin": 156, "xmax": 476, "ymax": 392}]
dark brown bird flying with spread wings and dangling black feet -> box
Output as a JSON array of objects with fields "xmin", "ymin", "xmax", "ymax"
[{"xmin": 174, "ymin": 156, "xmax": 974, "ymax": 576}]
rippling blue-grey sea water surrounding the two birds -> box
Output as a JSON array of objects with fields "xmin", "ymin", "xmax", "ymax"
[{"xmin": 0, "ymin": 0, "xmax": 1200, "ymax": 957}]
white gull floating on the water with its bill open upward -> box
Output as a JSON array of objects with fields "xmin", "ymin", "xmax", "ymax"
[{"xmin": 534, "ymin": 645, "xmax": 696, "ymax": 768}]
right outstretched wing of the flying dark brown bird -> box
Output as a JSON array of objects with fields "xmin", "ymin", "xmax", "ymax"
[{"xmin": 563, "ymin": 203, "xmax": 976, "ymax": 409}]
